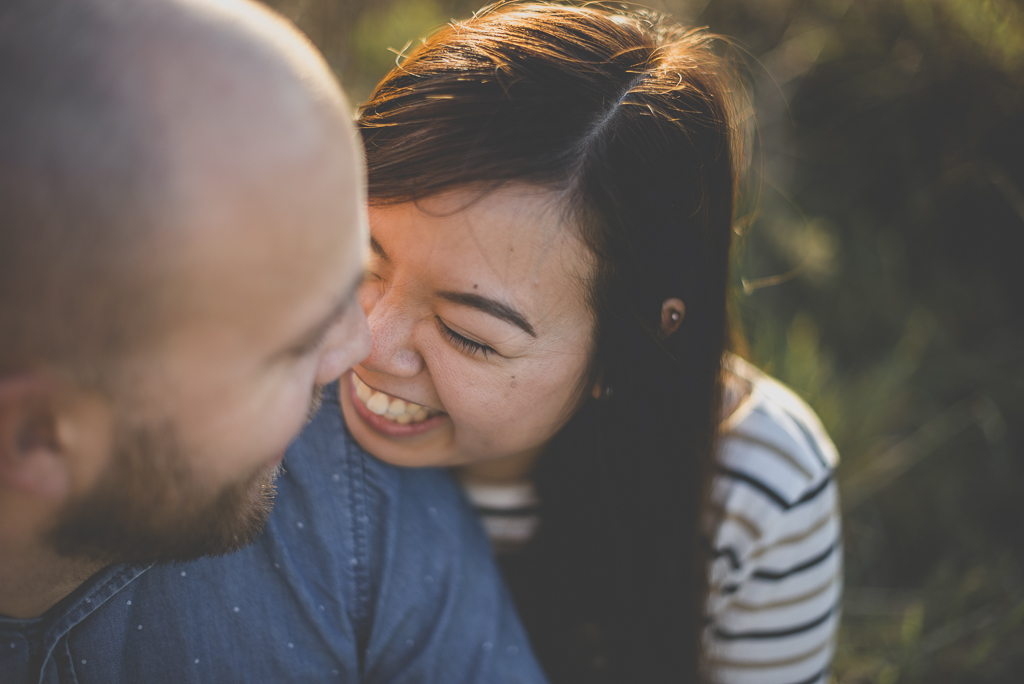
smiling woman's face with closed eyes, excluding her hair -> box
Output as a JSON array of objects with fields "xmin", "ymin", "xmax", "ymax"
[{"xmin": 341, "ymin": 184, "xmax": 594, "ymax": 466}]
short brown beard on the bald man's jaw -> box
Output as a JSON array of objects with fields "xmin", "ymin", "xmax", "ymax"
[{"xmin": 43, "ymin": 386, "xmax": 323, "ymax": 565}]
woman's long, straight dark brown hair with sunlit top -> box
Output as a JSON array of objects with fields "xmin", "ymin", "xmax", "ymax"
[{"xmin": 359, "ymin": 3, "xmax": 738, "ymax": 683}]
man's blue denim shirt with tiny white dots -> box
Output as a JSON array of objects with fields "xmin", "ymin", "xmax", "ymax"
[{"xmin": 0, "ymin": 385, "xmax": 545, "ymax": 684}]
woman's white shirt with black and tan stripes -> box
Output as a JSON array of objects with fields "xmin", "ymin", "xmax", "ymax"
[{"xmin": 464, "ymin": 356, "xmax": 843, "ymax": 684}]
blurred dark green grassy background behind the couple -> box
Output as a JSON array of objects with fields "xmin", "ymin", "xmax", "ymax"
[{"xmin": 253, "ymin": 0, "xmax": 1024, "ymax": 684}]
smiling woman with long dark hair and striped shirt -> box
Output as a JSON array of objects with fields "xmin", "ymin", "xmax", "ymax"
[{"xmin": 342, "ymin": 3, "xmax": 840, "ymax": 684}]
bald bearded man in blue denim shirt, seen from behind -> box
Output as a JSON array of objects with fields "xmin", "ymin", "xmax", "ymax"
[{"xmin": 0, "ymin": 0, "xmax": 543, "ymax": 684}]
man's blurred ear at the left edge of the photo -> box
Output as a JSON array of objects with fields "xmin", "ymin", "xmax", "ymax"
[{"xmin": 0, "ymin": 375, "xmax": 72, "ymax": 499}]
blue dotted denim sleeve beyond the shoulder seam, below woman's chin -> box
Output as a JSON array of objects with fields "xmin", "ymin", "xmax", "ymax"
[{"xmin": 353, "ymin": 448, "xmax": 547, "ymax": 684}]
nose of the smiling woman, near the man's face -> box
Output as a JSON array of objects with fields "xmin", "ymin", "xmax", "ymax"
[{"xmin": 360, "ymin": 289, "xmax": 423, "ymax": 378}]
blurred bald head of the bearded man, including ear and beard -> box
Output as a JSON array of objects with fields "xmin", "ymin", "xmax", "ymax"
[{"xmin": 0, "ymin": 0, "xmax": 369, "ymax": 562}]
